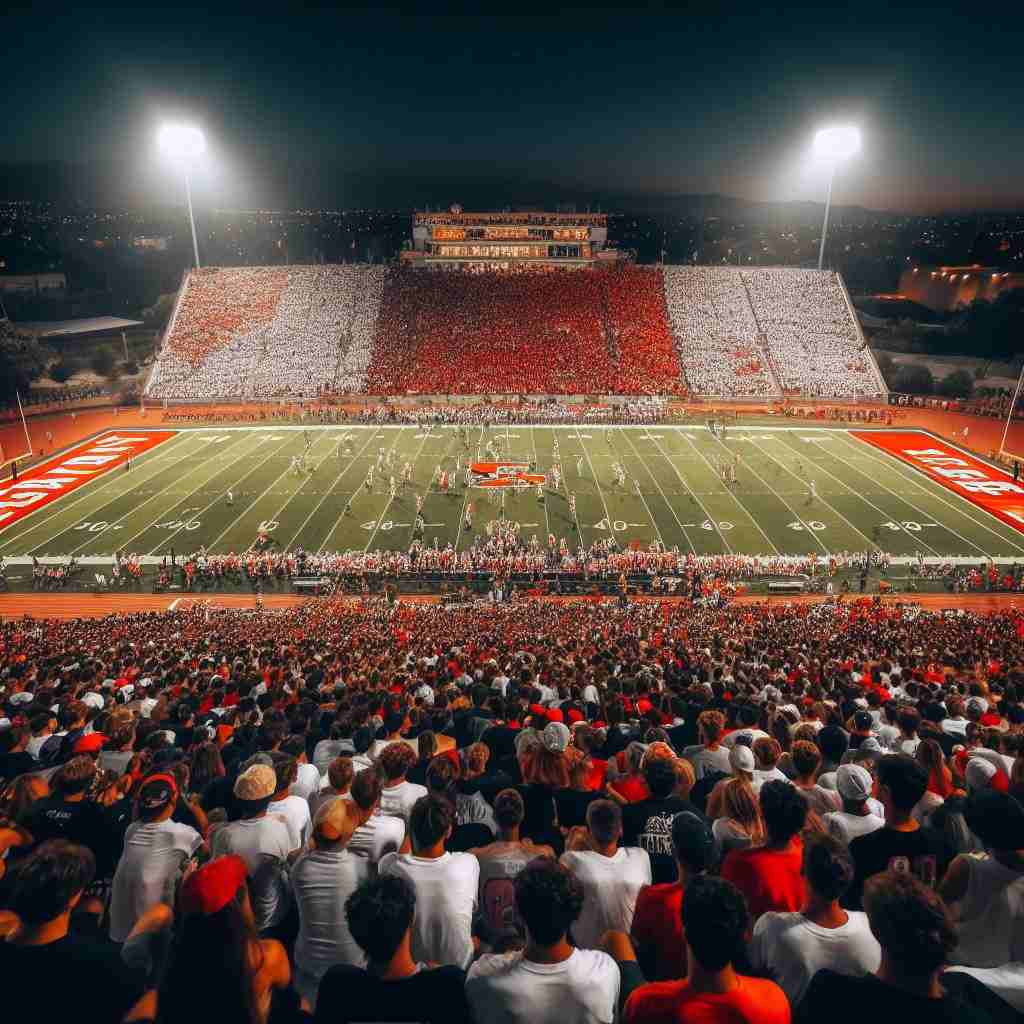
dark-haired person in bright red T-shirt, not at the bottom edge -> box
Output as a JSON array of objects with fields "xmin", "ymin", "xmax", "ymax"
[{"xmin": 722, "ymin": 780, "xmax": 807, "ymax": 924}]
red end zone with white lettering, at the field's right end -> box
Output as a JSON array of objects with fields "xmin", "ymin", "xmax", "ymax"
[{"xmin": 850, "ymin": 430, "xmax": 1024, "ymax": 532}]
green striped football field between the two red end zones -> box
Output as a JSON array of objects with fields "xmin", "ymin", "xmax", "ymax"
[{"xmin": 0, "ymin": 426, "xmax": 1024, "ymax": 559}]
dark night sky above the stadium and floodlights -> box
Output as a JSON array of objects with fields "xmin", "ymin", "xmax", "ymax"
[{"xmin": 8, "ymin": 0, "xmax": 1024, "ymax": 212}]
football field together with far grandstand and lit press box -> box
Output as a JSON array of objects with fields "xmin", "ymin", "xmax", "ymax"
[{"xmin": 0, "ymin": 206, "xmax": 1024, "ymax": 595}]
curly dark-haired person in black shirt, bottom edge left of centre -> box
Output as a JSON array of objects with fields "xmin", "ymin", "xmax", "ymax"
[{"xmin": 315, "ymin": 874, "xmax": 469, "ymax": 1024}]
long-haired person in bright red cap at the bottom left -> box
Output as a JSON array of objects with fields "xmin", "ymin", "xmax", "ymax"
[{"xmin": 157, "ymin": 855, "xmax": 292, "ymax": 1024}]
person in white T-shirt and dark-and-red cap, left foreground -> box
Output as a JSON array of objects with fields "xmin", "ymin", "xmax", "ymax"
[{"xmin": 111, "ymin": 772, "xmax": 203, "ymax": 942}]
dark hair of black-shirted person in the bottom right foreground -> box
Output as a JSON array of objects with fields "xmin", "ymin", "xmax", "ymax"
[{"xmin": 864, "ymin": 871, "xmax": 956, "ymax": 978}]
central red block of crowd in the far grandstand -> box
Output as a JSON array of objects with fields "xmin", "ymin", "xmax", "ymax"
[{"xmin": 368, "ymin": 266, "xmax": 685, "ymax": 394}]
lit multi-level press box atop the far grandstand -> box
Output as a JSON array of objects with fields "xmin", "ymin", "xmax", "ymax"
[{"xmin": 401, "ymin": 206, "xmax": 621, "ymax": 271}]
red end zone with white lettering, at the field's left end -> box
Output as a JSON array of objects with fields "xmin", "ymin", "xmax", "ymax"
[{"xmin": 0, "ymin": 430, "xmax": 177, "ymax": 530}]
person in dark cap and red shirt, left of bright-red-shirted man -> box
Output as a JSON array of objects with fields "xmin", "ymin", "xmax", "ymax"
[{"xmin": 633, "ymin": 811, "xmax": 715, "ymax": 981}]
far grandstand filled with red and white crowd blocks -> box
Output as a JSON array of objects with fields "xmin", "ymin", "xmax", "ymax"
[{"xmin": 146, "ymin": 264, "xmax": 885, "ymax": 400}]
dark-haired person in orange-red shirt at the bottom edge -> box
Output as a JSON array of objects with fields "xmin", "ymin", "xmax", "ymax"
[{"xmin": 624, "ymin": 872, "xmax": 800, "ymax": 1024}]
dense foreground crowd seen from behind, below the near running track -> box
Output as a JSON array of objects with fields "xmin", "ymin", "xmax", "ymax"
[{"xmin": 0, "ymin": 600, "xmax": 1024, "ymax": 1024}]
